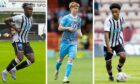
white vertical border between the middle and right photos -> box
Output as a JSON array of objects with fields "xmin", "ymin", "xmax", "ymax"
[{"xmin": 92, "ymin": 0, "xmax": 95, "ymax": 84}]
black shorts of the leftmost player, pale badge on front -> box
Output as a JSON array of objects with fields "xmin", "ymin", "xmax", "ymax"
[{"xmin": 12, "ymin": 42, "xmax": 33, "ymax": 56}]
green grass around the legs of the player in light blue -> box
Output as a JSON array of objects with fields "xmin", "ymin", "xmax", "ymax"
[{"xmin": 48, "ymin": 58, "xmax": 92, "ymax": 84}]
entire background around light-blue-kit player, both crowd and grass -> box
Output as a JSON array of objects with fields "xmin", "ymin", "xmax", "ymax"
[{"xmin": 47, "ymin": 0, "xmax": 93, "ymax": 84}]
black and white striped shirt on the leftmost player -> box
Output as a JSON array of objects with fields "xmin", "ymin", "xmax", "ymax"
[{"xmin": 12, "ymin": 14, "xmax": 32, "ymax": 43}]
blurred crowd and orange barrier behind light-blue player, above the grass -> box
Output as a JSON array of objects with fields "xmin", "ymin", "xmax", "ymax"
[{"xmin": 47, "ymin": 0, "xmax": 93, "ymax": 58}]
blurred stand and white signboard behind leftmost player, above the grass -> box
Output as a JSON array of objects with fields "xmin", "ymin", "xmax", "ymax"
[{"xmin": 0, "ymin": 0, "xmax": 46, "ymax": 40}]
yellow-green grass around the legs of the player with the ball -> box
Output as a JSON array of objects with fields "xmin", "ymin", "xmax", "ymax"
[{"xmin": 95, "ymin": 56, "xmax": 140, "ymax": 84}]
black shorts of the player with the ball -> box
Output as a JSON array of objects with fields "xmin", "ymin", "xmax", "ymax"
[{"xmin": 104, "ymin": 44, "xmax": 125, "ymax": 60}]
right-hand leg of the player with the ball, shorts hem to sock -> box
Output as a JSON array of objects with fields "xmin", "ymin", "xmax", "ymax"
[{"xmin": 116, "ymin": 45, "xmax": 126, "ymax": 72}]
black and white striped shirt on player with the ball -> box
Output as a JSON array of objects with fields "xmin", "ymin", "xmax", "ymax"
[{"xmin": 104, "ymin": 16, "xmax": 125, "ymax": 47}]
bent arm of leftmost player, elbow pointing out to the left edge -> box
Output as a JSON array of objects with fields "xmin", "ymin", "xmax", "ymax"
[{"xmin": 4, "ymin": 17, "xmax": 21, "ymax": 32}]
